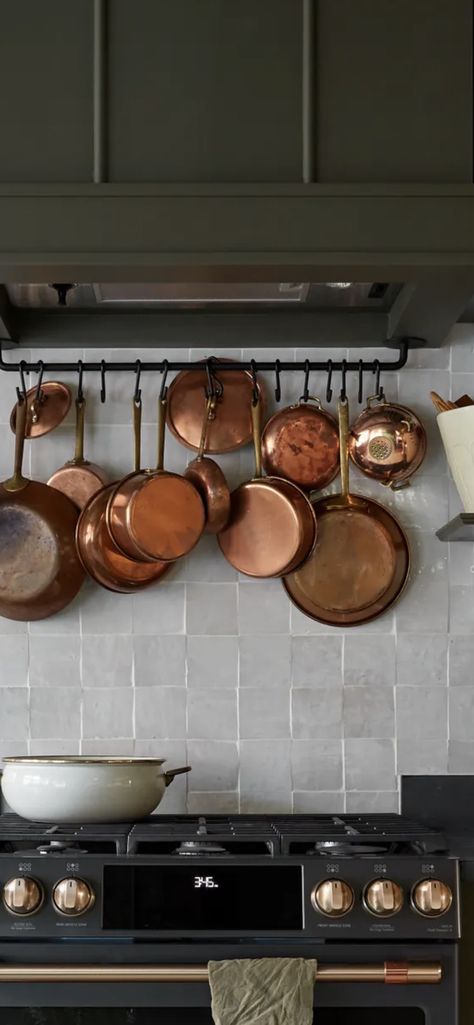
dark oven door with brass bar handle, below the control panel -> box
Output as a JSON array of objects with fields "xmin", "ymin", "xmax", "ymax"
[{"xmin": 0, "ymin": 943, "xmax": 458, "ymax": 1025}]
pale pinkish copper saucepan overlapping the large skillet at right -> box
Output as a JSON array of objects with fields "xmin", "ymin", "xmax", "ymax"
[{"xmin": 218, "ymin": 398, "xmax": 316, "ymax": 577}]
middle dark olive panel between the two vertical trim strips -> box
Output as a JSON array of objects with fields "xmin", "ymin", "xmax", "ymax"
[{"xmin": 108, "ymin": 0, "xmax": 302, "ymax": 182}]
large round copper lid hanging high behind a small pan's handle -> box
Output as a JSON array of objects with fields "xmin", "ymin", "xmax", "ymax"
[{"xmin": 167, "ymin": 360, "xmax": 265, "ymax": 454}]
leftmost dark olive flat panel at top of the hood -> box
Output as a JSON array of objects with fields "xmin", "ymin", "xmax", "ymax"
[{"xmin": 0, "ymin": 0, "xmax": 92, "ymax": 182}]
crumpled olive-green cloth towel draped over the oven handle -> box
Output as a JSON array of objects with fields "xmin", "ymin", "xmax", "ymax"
[{"xmin": 208, "ymin": 957, "xmax": 317, "ymax": 1025}]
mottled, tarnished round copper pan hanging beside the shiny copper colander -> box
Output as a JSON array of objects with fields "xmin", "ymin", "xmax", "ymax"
[{"xmin": 262, "ymin": 399, "xmax": 339, "ymax": 491}]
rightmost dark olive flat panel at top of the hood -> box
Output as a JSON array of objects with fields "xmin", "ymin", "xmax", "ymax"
[{"xmin": 316, "ymin": 0, "xmax": 473, "ymax": 183}]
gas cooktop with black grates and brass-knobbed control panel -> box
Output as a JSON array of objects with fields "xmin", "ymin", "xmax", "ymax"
[{"xmin": 0, "ymin": 815, "xmax": 460, "ymax": 943}]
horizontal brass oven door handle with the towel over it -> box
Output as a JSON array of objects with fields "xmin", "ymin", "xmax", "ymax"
[{"xmin": 0, "ymin": 961, "xmax": 442, "ymax": 986}]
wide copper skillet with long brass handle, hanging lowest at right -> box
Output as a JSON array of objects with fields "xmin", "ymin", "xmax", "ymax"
[{"xmin": 283, "ymin": 402, "xmax": 409, "ymax": 626}]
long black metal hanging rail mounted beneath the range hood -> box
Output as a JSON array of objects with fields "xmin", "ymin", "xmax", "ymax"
[{"xmin": 0, "ymin": 337, "xmax": 410, "ymax": 383}]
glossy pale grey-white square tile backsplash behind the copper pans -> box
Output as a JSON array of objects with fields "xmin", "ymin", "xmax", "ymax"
[{"xmin": 0, "ymin": 325, "xmax": 474, "ymax": 812}]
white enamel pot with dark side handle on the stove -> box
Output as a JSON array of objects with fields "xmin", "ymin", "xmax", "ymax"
[{"xmin": 2, "ymin": 755, "xmax": 190, "ymax": 824}]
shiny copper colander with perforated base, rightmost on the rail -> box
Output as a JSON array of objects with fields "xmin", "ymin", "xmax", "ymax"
[{"xmin": 349, "ymin": 396, "xmax": 427, "ymax": 489}]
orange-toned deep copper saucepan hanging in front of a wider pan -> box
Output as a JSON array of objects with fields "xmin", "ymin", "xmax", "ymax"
[{"xmin": 107, "ymin": 393, "xmax": 205, "ymax": 562}]
